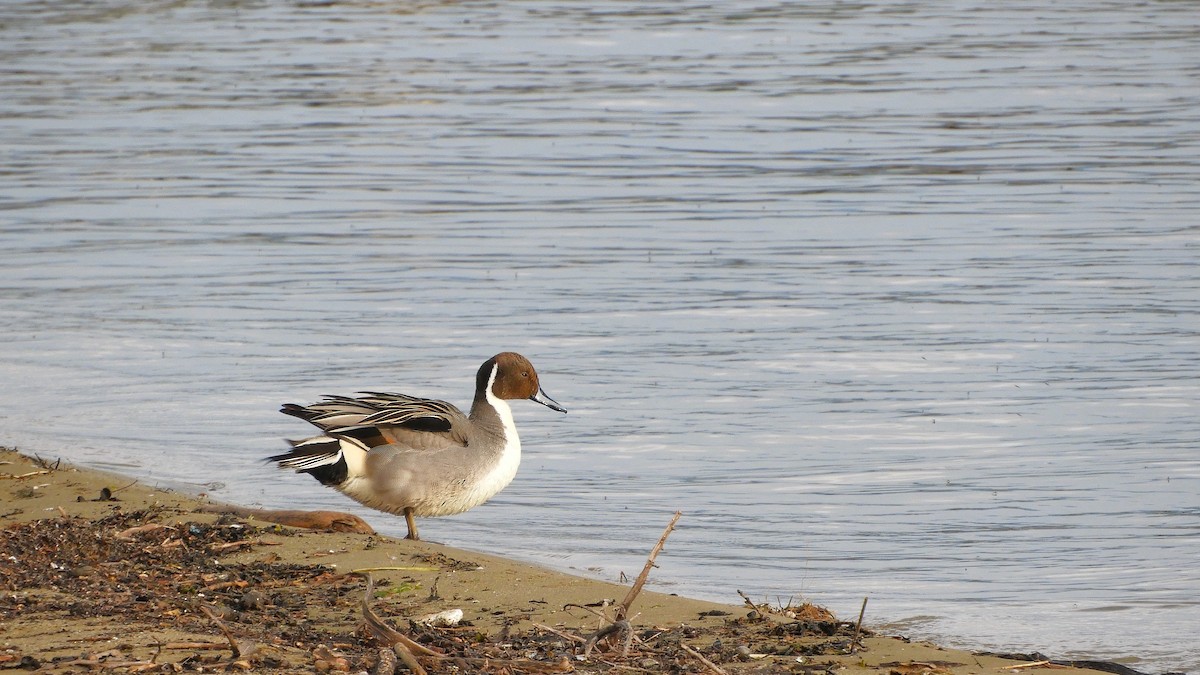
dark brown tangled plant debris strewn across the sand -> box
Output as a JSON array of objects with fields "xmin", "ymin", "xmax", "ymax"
[{"xmin": 0, "ymin": 507, "xmax": 854, "ymax": 673}]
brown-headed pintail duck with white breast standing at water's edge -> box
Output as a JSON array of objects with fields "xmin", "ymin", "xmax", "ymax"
[{"xmin": 268, "ymin": 352, "xmax": 566, "ymax": 539}]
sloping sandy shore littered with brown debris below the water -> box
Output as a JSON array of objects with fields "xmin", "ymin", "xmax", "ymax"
[{"xmin": 0, "ymin": 450, "xmax": 1137, "ymax": 675}]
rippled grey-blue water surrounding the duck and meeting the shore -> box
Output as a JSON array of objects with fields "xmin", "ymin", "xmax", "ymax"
[{"xmin": 0, "ymin": 0, "xmax": 1200, "ymax": 671}]
